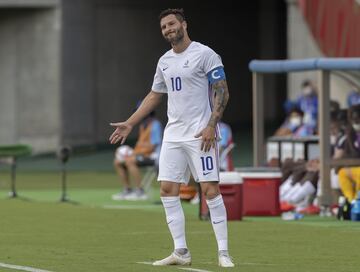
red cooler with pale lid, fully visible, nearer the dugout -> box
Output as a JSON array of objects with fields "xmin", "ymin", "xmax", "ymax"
[{"xmin": 237, "ymin": 168, "xmax": 281, "ymax": 216}]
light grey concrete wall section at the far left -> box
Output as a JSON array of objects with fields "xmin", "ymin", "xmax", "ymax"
[{"xmin": 0, "ymin": 6, "xmax": 60, "ymax": 152}]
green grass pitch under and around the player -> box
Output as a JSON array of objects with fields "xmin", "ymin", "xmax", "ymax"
[{"xmin": 0, "ymin": 150, "xmax": 360, "ymax": 272}]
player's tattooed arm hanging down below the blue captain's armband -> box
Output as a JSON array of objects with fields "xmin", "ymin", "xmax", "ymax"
[{"xmin": 195, "ymin": 79, "xmax": 229, "ymax": 152}]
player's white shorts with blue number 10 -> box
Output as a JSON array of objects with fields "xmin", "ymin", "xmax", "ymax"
[{"xmin": 158, "ymin": 140, "xmax": 219, "ymax": 183}]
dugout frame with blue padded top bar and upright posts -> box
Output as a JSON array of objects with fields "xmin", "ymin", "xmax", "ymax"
[{"xmin": 249, "ymin": 58, "xmax": 360, "ymax": 206}]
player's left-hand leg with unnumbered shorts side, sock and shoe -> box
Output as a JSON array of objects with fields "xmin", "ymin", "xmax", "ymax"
[{"xmin": 153, "ymin": 142, "xmax": 191, "ymax": 265}]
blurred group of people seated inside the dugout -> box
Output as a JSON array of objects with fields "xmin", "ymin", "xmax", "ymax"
[{"xmin": 274, "ymin": 80, "xmax": 360, "ymax": 219}]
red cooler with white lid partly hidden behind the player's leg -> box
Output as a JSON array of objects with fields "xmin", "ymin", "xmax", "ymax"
[{"xmin": 200, "ymin": 172, "xmax": 243, "ymax": 220}]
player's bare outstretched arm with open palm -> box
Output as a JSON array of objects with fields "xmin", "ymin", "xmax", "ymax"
[{"xmin": 109, "ymin": 91, "xmax": 163, "ymax": 144}]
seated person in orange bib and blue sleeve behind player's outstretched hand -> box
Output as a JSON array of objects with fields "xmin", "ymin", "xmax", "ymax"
[{"xmin": 112, "ymin": 107, "xmax": 163, "ymax": 200}]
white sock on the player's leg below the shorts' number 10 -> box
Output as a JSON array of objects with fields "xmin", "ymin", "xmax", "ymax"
[{"xmin": 206, "ymin": 195, "xmax": 228, "ymax": 251}]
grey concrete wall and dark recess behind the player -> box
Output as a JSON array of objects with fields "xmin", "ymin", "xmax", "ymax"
[{"xmin": 0, "ymin": 0, "xmax": 285, "ymax": 153}]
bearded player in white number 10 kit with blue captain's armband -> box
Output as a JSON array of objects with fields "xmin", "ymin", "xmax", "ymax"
[{"xmin": 110, "ymin": 9, "xmax": 234, "ymax": 267}]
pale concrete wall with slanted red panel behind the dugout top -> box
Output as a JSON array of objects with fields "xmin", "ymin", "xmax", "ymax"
[{"xmin": 286, "ymin": 0, "xmax": 360, "ymax": 107}]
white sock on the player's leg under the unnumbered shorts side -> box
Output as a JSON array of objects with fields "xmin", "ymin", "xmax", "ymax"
[{"xmin": 161, "ymin": 196, "xmax": 187, "ymax": 250}]
